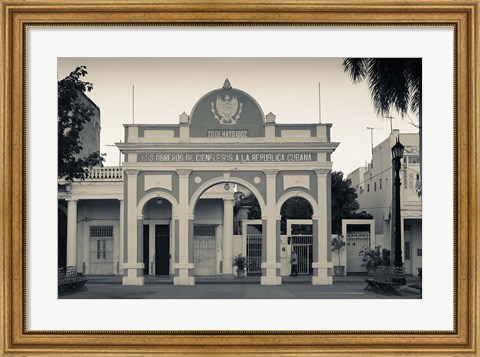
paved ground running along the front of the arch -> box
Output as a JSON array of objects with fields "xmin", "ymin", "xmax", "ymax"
[{"xmin": 61, "ymin": 277, "xmax": 421, "ymax": 299}]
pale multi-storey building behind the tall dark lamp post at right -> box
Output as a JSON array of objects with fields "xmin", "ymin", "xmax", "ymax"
[{"xmin": 348, "ymin": 130, "xmax": 422, "ymax": 274}]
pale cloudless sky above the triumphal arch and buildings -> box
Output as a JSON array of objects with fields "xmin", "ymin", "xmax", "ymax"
[{"xmin": 58, "ymin": 57, "xmax": 418, "ymax": 175}]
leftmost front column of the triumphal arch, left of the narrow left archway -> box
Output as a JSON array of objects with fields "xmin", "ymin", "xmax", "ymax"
[{"xmin": 122, "ymin": 170, "xmax": 145, "ymax": 285}]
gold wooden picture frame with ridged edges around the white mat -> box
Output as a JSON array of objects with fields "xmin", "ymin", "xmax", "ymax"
[{"xmin": 0, "ymin": 0, "xmax": 480, "ymax": 356}]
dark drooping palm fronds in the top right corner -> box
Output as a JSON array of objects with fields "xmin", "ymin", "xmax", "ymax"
[{"xmin": 342, "ymin": 58, "xmax": 422, "ymax": 195}]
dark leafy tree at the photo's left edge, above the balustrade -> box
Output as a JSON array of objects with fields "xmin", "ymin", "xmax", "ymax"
[{"xmin": 57, "ymin": 66, "xmax": 103, "ymax": 181}]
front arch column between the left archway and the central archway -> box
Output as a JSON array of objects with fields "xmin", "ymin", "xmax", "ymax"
[{"xmin": 173, "ymin": 169, "xmax": 195, "ymax": 285}]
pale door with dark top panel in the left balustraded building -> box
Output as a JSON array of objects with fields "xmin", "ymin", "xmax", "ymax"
[{"xmin": 88, "ymin": 226, "xmax": 113, "ymax": 275}]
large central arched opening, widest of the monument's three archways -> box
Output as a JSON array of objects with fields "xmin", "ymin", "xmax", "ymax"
[{"xmin": 190, "ymin": 178, "xmax": 264, "ymax": 276}]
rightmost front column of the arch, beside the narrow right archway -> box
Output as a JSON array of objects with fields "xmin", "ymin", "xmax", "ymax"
[{"xmin": 312, "ymin": 169, "xmax": 333, "ymax": 285}]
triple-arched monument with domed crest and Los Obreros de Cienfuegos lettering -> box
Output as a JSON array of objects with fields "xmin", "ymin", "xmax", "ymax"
[{"xmin": 117, "ymin": 80, "xmax": 338, "ymax": 285}]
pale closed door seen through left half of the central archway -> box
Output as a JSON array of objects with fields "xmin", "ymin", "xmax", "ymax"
[{"xmin": 193, "ymin": 224, "xmax": 217, "ymax": 276}]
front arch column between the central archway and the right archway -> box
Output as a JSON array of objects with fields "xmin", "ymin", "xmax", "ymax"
[{"xmin": 261, "ymin": 170, "xmax": 282, "ymax": 285}]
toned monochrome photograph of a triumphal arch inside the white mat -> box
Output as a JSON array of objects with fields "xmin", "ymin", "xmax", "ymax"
[{"xmin": 57, "ymin": 57, "xmax": 422, "ymax": 300}]
